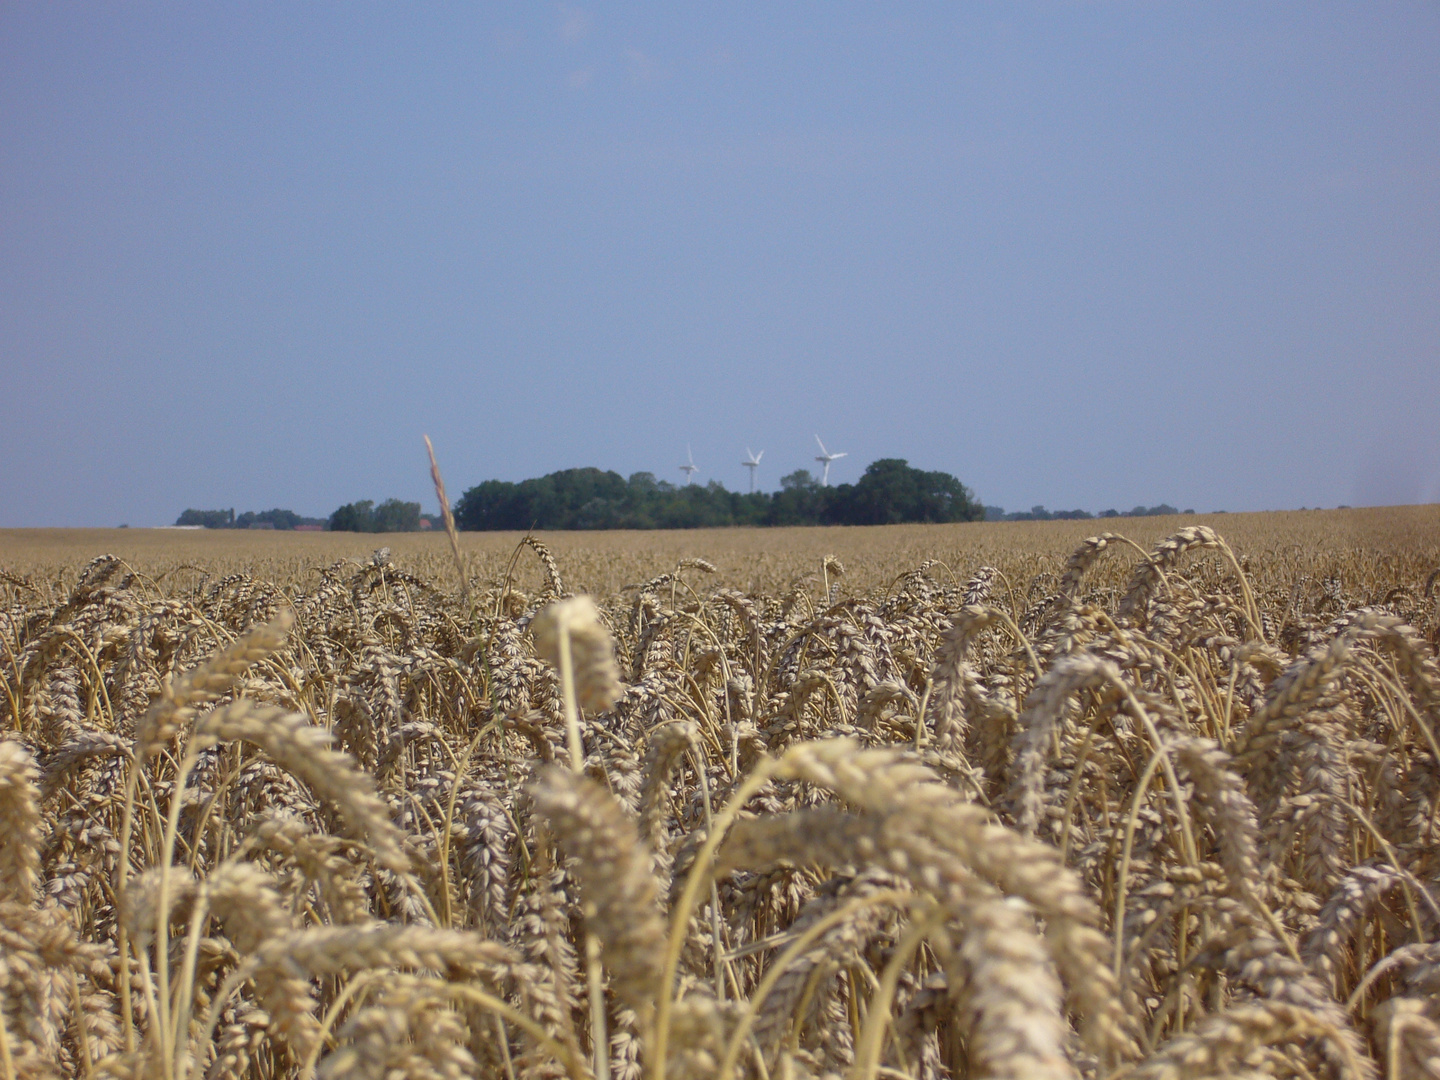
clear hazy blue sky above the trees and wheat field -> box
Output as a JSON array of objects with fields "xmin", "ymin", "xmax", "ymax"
[{"xmin": 0, "ymin": 0, "xmax": 1440, "ymax": 526}]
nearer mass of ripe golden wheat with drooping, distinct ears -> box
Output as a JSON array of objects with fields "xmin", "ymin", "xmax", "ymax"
[{"xmin": 0, "ymin": 526, "xmax": 1440, "ymax": 1080}]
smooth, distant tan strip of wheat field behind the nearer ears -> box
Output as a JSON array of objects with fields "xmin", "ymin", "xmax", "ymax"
[{"xmin": 0, "ymin": 505, "xmax": 1440, "ymax": 596}]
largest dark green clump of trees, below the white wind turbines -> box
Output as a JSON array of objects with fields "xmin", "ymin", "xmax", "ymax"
[{"xmin": 455, "ymin": 458, "xmax": 985, "ymax": 530}]
